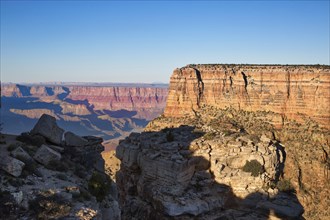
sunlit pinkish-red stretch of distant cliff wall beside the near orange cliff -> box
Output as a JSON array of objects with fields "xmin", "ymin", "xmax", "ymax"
[{"xmin": 67, "ymin": 86, "xmax": 167, "ymax": 120}]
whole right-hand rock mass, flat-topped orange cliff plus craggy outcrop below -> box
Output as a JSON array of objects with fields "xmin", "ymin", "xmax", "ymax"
[{"xmin": 116, "ymin": 65, "xmax": 330, "ymax": 219}]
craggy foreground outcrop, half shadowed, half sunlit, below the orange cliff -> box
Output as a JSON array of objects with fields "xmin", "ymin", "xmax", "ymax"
[{"xmin": 116, "ymin": 125, "xmax": 303, "ymax": 219}]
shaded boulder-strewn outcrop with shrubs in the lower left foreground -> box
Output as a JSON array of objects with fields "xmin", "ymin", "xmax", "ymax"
[{"xmin": 0, "ymin": 115, "xmax": 121, "ymax": 220}]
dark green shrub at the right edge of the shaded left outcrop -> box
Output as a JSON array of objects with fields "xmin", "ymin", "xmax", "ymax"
[{"xmin": 88, "ymin": 172, "xmax": 111, "ymax": 202}]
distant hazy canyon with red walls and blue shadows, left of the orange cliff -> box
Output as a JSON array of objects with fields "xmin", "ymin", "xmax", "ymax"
[{"xmin": 1, "ymin": 83, "xmax": 167, "ymax": 150}]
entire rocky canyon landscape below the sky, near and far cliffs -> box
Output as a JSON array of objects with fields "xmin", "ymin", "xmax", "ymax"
[{"xmin": 0, "ymin": 64, "xmax": 330, "ymax": 220}]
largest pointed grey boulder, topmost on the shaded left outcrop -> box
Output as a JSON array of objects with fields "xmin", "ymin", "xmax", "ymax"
[{"xmin": 30, "ymin": 114, "xmax": 64, "ymax": 145}]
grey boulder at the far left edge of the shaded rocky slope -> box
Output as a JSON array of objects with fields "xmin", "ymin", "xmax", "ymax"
[{"xmin": 0, "ymin": 156, "xmax": 25, "ymax": 177}]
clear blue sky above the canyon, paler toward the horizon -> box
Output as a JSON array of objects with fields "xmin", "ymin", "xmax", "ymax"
[{"xmin": 1, "ymin": 1, "xmax": 330, "ymax": 83}]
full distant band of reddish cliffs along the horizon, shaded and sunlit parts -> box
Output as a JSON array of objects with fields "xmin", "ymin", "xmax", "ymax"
[{"xmin": 2, "ymin": 84, "xmax": 167, "ymax": 120}]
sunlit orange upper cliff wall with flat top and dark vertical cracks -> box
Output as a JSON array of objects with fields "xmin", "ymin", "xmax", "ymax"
[{"xmin": 165, "ymin": 65, "xmax": 330, "ymax": 127}]
